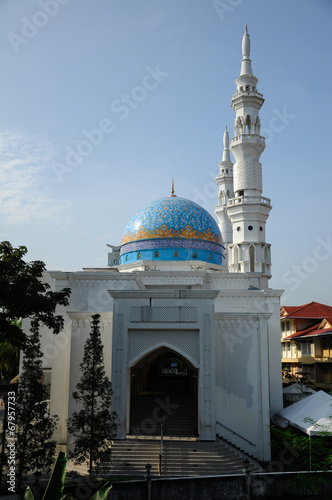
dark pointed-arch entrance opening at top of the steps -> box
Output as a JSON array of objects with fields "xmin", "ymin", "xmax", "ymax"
[{"xmin": 130, "ymin": 347, "xmax": 198, "ymax": 436}]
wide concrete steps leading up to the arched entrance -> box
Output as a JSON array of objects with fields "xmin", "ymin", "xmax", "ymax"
[{"xmin": 68, "ymin": 437, "xmax": 261, "ymax": 478}]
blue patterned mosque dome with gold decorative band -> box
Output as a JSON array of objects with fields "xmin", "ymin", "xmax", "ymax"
[{"xmin": 120, "ymin": 196, "xmax": 224, "ymax": 264}]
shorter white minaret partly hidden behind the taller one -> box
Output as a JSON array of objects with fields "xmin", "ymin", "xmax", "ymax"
[{"xmin": 215, "ymin": 125, "xmax": 234, "ymax": 266}]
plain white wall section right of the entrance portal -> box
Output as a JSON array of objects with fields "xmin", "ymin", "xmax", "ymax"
[{"xmin": 216, "ymin": 313, "xmax": 270, "ymax": 460}]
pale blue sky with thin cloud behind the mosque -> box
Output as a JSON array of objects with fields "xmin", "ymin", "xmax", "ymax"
[{"xmin": 0, "ymin": 0, "xmax": 332, "ymax": 305}]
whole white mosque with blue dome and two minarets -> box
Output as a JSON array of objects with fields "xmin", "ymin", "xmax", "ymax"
[{"xmin": 42, "ymin": 27, "xmax": 282, "ymax": 461}]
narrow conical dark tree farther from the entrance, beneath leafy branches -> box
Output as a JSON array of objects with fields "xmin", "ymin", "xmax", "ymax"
[{"xmin": 16, "ymin": 319, "xmax": 58, "ymax": 484}]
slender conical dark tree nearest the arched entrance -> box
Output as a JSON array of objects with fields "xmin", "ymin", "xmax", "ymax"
[{"xmin": 68, "ymin": 314, "xmax": 117, "ymax": 473}]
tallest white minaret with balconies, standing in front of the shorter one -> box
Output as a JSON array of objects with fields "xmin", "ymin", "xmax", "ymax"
[{"xmin": 227, "ymin": 24, "xmax": 272, "ymax": 278}]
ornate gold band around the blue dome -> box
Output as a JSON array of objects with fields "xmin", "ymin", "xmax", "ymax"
[{"xmin": 121, "ymin": 224, "xmax": 222, "ymax": 245}]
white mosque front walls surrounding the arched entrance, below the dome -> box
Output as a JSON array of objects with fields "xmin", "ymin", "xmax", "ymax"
[{"xmin": 35, "ymin": 268, "xmax": 282, "ymax": 460}]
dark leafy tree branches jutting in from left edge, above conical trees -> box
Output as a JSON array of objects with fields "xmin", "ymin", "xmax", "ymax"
[{"xmin": 0, "ymin": 241, "xmax": 70, "ymax": 347}]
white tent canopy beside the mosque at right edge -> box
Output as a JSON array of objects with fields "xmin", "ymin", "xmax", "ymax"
[{"xmin": 274, "ymin": 391, "xmax": 332, "ymax": 436}]
